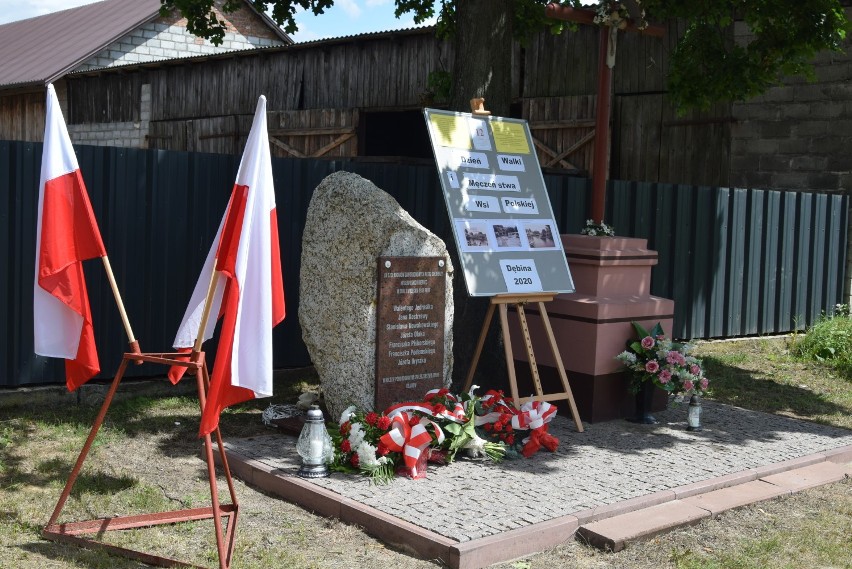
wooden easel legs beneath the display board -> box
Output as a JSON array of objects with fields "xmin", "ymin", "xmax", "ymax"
[{"xmin": 464, "ymin": 292, "xmax": 583, "ymax": 433}]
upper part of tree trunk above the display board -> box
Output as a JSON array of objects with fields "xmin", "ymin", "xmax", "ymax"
[{"xmin": 450, "ymin": 0, "xmax": 512, "ymax": 116}]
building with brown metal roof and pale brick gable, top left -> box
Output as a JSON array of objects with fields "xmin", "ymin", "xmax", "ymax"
[{"xmin": 0, "ymin": 0, "xmax": 292, "ymax": 146}]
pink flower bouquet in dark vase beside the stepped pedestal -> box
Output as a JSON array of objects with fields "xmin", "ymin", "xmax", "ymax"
[{"xmin": 615, "ymin": 322, "xmax": 710, "ymax": 395}]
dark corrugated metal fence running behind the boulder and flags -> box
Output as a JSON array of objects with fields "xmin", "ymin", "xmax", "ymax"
[{"xmin": 0, "ymin": 141, "xmax": 848, "ymax": 387}]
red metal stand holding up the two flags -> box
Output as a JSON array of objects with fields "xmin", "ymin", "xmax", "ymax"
[{"xmin": 41, "ymin": 352, "xmax": 239, "ymax": 569}]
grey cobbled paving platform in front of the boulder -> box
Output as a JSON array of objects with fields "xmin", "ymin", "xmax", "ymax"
[{"xmin": 227, "ymin": 401, "xmax": 852, "ymax": 568}]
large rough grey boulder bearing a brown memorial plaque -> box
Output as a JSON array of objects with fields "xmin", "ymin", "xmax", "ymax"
[{"xmin": 299, "ymin": 172, "xmax": 453, "ymax": 418}]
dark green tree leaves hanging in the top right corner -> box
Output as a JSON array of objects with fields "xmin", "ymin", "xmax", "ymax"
[{"xmin": 646, "ymin": 0, "xmax": 849, "ymax": 111}]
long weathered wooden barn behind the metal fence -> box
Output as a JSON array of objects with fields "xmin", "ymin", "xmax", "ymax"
[{"xmin": 0, "ymin": 0, "xmax": 852, "ymax": 192}]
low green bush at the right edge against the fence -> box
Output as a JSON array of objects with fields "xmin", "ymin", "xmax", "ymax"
[{"xmin": 792, "ymin": 308, "xmax": 852, "ymax": 377}]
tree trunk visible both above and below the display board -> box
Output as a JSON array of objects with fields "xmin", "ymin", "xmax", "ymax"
[{"xmin": 450, "ymin": 0, "xmax": 512, "ymax": 388}]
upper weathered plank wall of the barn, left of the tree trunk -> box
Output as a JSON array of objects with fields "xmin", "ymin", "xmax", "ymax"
[{"xmin": 150, "ymin": 30, "xmax": 452, "ymax": 121}]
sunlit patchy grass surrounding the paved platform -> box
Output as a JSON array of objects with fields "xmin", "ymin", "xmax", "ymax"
[{"xmin": 0, "ymin": 338, "xmax": 852, "ymax": 569}]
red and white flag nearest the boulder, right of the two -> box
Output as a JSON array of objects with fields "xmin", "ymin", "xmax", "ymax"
[{"xmin": 170, "ymin": 96, "xmax": 284, "ymax": 436}]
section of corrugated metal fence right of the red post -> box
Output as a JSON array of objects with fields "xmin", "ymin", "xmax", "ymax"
[{"xmin": 604, "ymin": 181, "xmax": 848, "ymax": 338}]
